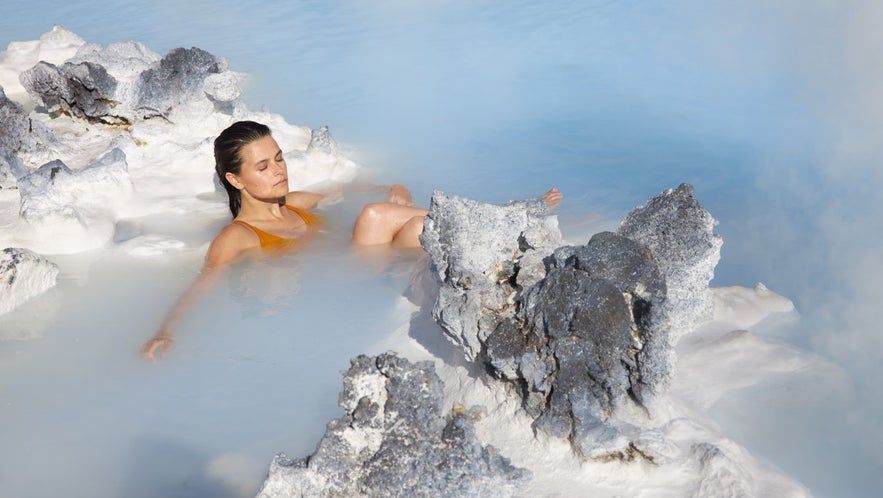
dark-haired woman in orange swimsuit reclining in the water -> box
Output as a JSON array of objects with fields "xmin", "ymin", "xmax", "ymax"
[{"xmin": 142, "ymin": 121, "xmax": 562, "ymax": 362}]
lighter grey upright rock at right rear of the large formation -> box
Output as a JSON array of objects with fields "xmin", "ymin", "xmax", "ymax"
[{"xmin": 618, "ymin": 183, "xmax": 723, "ymax": 342}]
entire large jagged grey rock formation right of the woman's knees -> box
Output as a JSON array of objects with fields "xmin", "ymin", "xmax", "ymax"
[{"xmin": 421, "ymin": 185, "xmax": 720, "ymax": 461}]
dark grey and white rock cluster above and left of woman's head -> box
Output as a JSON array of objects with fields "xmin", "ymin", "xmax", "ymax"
[{"xmin": 20, "ymin": 41, "xmax": 240, "ymax": 125}]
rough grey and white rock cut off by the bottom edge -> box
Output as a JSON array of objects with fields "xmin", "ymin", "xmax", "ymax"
[{"xmin": 258, "ymin": 354, "xmax": 530, "ymax": 498}]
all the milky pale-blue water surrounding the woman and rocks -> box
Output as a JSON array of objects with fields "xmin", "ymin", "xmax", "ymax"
[{"xmin": 0, "ymin": 0, "xmax": 883, "ymax": 497}]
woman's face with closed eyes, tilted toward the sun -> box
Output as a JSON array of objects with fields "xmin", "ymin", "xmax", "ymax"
[{"xmin": 227, "ymin": 136, "xmax": 288, "ymax": 200}]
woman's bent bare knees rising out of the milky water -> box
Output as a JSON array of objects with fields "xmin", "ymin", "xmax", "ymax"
[{"xmin": 353, "ymin": 202, "xmax": 428, "ymax": 247}]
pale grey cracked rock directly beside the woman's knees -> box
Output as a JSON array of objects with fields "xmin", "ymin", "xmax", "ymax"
[{"xmin": 420, "ymin": 191, "xmax": 561, "ymax": 360}]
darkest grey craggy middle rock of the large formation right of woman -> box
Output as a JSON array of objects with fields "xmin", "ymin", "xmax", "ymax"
[{"xmin": 516, "ymin": 232, "xmax": 673, "ymax": 458}]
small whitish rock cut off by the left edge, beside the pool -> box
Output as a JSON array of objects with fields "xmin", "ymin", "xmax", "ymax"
[{"xmin": 0, "ymin": 247, "xmax": 58, "ymax": 315}]
